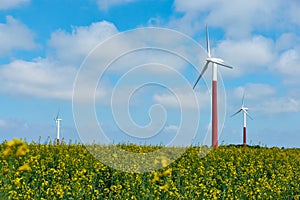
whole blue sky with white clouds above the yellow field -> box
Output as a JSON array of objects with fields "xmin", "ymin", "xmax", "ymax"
[{"xmin": 0, "ymin": 0, "xmax": 300, "ymax": 147}]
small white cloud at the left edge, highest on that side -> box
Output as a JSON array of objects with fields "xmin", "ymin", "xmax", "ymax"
[{"xmin": 0, "ymin": 16, "xmax": 37, "ymax": 57}]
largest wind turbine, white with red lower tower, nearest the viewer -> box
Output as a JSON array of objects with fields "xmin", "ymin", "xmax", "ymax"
[{"xmin": 193, "ymin": 25, "xmax": 232, "ymax": 148}]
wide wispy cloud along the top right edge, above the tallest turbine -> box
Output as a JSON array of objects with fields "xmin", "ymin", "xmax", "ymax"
[{"xmin": 171, "ymin": 0, "xmax": 300, "ymax": 39}]
